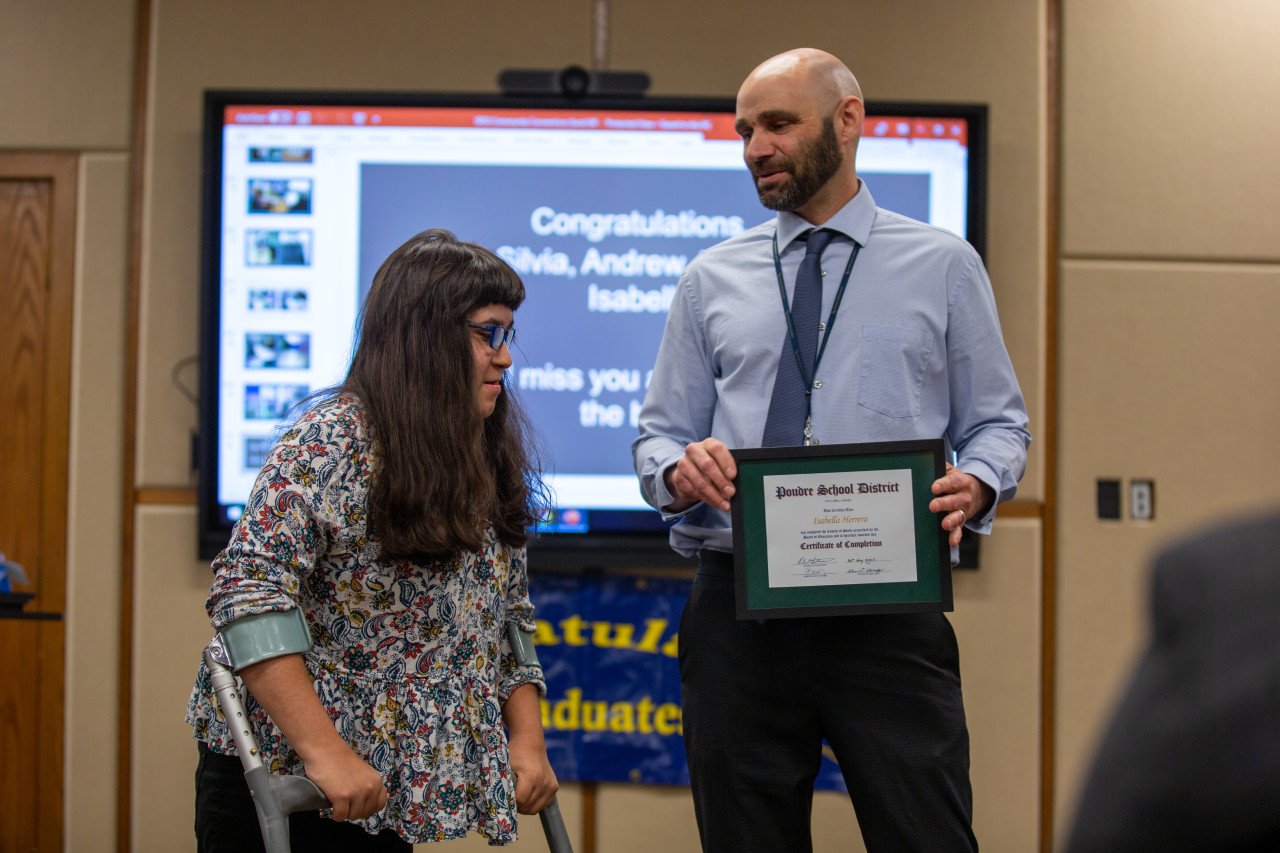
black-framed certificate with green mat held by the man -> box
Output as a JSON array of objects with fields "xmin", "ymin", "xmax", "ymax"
[{"xmin": 732, "ymin": 438, "xmax": 954, "ymax": 619}]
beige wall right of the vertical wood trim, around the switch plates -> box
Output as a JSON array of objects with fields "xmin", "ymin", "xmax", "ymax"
[{"xmin": 1056, "ymin": 0, "xmax": 1280, "ymax": 840}]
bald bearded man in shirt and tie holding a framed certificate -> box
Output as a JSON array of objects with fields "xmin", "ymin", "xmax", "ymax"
[{"xmin": 632, "ymin": 49, "xmax": 1030, "ymax": 853}]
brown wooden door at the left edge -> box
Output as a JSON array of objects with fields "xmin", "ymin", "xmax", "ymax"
[{"xmin": 0, "ymin": 155, "xmax": 76, "ymax": 853}]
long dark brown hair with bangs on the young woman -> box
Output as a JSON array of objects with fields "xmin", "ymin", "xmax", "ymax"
[{"xmin": 337, "ymin": 228, "xmax": 543, "ymax": 560}]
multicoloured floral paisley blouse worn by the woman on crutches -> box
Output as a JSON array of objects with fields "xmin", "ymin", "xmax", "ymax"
[{"xmin": 187, "ymin": 397, "xmax": 545, "ymax": 844}]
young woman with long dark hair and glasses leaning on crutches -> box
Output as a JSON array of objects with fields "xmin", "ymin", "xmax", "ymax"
[{"xmin": 187, "ymin": 231, "xmax": 557, "ymax": 853}]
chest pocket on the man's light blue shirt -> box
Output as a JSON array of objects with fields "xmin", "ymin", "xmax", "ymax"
[{"xmin": 858, "ymin": 325, "xmax": 933, "ymax": 418}]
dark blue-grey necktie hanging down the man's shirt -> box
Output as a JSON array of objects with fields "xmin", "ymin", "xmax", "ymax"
[{"xmin": 760, "ymin": 229, "xmax": 835, "ymax": 447}]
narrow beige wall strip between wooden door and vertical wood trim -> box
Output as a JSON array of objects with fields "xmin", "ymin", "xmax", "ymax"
[{"xmin": 63, "ymin": 154, "xmax": 129, "ymax": 850}]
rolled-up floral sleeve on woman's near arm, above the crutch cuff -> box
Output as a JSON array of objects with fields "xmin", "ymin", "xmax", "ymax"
[{"xmin": 205, "ymin": 412, "xmax": 351, "ymax": 630}]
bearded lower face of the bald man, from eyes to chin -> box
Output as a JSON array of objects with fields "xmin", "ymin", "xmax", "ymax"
[{"xmin": 742, "ymin": 115, "xmax": 845, "ymax": 211}]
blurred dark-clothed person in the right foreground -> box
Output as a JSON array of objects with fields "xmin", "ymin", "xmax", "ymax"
[{"xmin": 1066, "ymin": 512, "xmax": 1280, "ymax": 853}]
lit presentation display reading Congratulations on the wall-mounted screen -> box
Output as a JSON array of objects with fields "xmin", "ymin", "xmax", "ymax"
[{"xmin": 218, "ymin": 108, "xmax": 966, "ymax": 517}]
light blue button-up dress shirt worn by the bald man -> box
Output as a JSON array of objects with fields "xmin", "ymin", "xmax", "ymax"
[{"xmin": 631, "ymin": 184, "xmax": 1030, "ymax": 556}]
